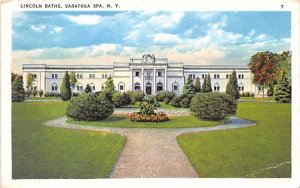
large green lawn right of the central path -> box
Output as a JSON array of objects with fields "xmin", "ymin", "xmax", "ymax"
[{"xmin": 177, "ymin": 102, "xmax": 291, "ymax": 178}]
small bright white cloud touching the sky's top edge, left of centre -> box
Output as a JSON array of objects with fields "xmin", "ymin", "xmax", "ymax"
[{"xmin": 64, "ymin": 15, "xmax": 102, "ymax": 25}]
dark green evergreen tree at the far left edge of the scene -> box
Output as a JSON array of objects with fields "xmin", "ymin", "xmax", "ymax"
[{"xmin": 11, "ymin": 75, "xmax": 25, "ymax": 102}]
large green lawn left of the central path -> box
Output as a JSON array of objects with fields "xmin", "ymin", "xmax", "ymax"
[{"xmin": 12, "ymin": 102, "xmax": 126, "ymax": 179}]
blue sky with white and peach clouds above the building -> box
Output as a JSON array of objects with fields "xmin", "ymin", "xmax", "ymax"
[{"xmin": 12, "ymin": 11, "xmax": 291, "ymax": 72}]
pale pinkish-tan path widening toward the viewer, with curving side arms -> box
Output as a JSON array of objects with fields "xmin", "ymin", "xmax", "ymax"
[{"xmin": 44, "ymin": 117, "xmax": 255, "ymax": 178}]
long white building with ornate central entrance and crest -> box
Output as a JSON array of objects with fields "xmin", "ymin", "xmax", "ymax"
[{"xmin": 23, "ymin": 54, "xmax": 261, "ymax": 95}]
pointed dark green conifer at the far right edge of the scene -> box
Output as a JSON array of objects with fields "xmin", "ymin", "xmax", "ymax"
[{"xmin": 275, "ymin": 71, "xmax": 291, "ymax": 103}]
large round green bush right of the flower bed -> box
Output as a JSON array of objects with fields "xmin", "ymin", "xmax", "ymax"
[{"xmin": 190, "ymin": 93, "xmax": 237, "ymax": 120}]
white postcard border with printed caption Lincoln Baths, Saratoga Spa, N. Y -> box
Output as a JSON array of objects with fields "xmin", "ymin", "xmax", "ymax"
[{"xmin": 0, "ymin": 0, "xmax": 300, "ymax": 188}]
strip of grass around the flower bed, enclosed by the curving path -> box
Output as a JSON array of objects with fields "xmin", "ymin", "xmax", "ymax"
[{"xmin": 68, "ymin": 115, "xmax": 225, "ymax": 128}]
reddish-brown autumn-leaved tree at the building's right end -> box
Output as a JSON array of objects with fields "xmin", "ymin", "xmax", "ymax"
[{"xmin": 248, "ymin": 52, "xmax": 277, "ymax": 97}]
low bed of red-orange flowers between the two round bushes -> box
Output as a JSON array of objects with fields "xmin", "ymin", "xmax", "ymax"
[{"xmin": 127, "ymin": 112, "xmax": 169, "ymax": 122}]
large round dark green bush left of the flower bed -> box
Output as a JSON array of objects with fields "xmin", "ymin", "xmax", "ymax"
[{"xmin": 66, "ymin": 93, "xmax": 114, "ymax": 121}]
